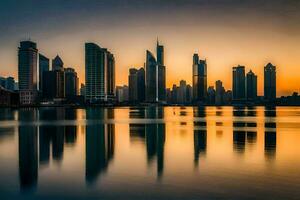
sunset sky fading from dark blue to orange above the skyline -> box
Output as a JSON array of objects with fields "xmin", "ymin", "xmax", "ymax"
[{"xmin": 0, "ymin": 0, "xmax": 300, "ymax": 95}]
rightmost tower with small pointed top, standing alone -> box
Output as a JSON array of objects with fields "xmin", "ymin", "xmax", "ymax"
[{"xmin": 264, "ymin": 63, "xmax": 276, "ymax": 102}]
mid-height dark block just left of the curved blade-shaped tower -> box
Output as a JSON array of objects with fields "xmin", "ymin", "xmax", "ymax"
[{"xmin": 128, "ymin": 68, "xmax": 145, "ymax": 103}]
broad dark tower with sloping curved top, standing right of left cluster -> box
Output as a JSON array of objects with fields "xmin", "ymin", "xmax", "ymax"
[{"xmin": 85, "ymin": 43, "xmax": 115, "ymax": 103}]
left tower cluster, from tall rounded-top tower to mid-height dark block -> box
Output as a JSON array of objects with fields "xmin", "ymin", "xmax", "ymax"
[{"xmin": 18, "ymin": 41, "xmax": 78, "ymax": 105}]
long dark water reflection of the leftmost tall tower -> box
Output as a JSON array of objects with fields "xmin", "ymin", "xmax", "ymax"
[{"xmin": 19, "ymin": 108, "xmax": 38, "ymax": 191}]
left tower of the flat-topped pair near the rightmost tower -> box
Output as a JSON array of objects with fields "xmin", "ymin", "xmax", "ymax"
[{"xmin": 232, "ymin": 65, "xmax": 246, "ymax": 101}]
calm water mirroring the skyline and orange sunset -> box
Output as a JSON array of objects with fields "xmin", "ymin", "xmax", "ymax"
[{"xmin": 0, "ymin": 107, "xmax": 300, "ymax": 199}]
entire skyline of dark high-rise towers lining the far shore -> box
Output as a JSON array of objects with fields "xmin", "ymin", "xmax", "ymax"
[{"xmin": 14, "ymin": 38, "xmax": 276, "ymax": 105}]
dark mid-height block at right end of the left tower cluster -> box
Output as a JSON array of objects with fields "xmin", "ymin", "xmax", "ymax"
[{"xmin": 64, "ymin": 68, "xmax": 78, "ymax": 99}]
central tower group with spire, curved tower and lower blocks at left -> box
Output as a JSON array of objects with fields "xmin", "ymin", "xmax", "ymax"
[{"xmin": 116, "ymin": 41, "xmax": 166, "ymax": 103}]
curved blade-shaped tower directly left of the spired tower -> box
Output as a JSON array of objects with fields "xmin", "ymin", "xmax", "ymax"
[{"xmin": 146, "ymin": 50, "xmax": 158, "ymax": 102}]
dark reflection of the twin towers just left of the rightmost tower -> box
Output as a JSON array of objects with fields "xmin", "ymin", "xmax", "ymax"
[{"xmin": 233, "ymin": 106, "xmax": 257, "ymax": 153}]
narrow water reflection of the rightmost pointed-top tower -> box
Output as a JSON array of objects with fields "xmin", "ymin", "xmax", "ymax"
[{"xmin": 265, "ymin": 107, "xmax": 276, "ymax": 160}]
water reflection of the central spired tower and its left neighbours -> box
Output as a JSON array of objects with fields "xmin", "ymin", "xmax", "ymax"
[{"xmin": 129, "ymin": 106, "xmax": 166, "ymax": 179}]
